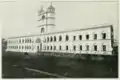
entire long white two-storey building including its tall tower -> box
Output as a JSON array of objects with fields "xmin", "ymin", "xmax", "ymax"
[{"xmin": 6, "ymin": 4, "xmax": 113, "ymax": 55}]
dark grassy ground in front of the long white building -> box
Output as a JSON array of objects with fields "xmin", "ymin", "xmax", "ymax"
[{"xmin": 2, "ymin": 52, "xmax": 118, "ymax": 78}]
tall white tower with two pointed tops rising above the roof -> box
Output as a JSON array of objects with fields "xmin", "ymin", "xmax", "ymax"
[{"xmin": 38, "ymin": 3, "xmax": 55, "ymax": 34}]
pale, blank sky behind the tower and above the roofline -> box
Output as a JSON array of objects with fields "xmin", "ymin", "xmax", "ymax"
[{"xmin": 0, "ymin": 0, "xmax": 118, "ymax": 39}]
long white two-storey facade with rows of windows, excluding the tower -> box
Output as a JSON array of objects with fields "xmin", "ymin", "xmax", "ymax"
[{"xmin": 7, "ymin": 27, "xmax": 112, "ymax": 55}]
